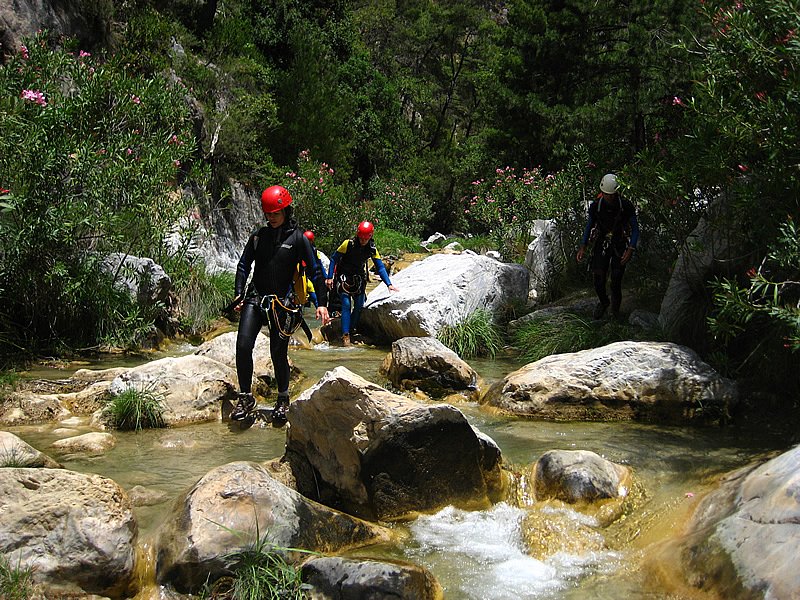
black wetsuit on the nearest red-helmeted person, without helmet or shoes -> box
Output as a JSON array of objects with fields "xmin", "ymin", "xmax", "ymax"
[{"xmin": 236, "ymin": 221, "xmax": 328, "ymax": 394}]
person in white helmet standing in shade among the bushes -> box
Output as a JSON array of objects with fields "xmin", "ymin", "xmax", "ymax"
[{"xmin": 577, "ymin": 173, "xmax": 639, "ymax": 319}]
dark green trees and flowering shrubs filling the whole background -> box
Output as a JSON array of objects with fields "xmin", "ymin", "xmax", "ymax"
[{"xmin": 0, "ymin": 0, "xmax": 800, "ymax": 398}]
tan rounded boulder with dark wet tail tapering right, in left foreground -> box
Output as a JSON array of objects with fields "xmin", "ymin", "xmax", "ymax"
[{"xmin": 156, "ymin": 462, "xmax": 389, "ymax": 592}]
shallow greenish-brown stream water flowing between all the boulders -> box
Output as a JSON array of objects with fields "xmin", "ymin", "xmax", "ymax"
[{"xmin": 11, "ymin": 344, "xmax": 785, "ymax": 600}]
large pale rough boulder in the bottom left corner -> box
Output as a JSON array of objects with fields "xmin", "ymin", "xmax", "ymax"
[{"xmin": 0, "ymin": 468, "xmax": 137, "ymax": 598}]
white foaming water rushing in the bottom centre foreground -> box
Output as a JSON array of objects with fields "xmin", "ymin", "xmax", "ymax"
[{"xmin": 406, "ymin": 503, "xmax": 619, "ymax": 600}]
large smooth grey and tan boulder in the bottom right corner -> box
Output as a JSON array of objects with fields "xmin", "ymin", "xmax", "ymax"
[{"xmin": 680, "ymin": 446, "xmax": 800, "ymax": 600}]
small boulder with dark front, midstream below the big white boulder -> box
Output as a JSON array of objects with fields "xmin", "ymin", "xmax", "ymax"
[{"xmin": 381, "ymin": 337, "xmax": 478, "ymax": 396}]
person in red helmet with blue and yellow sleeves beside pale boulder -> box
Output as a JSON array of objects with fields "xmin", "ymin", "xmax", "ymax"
[{"xmin": 325, "ymin": 221, "xmax": 397, "ymax": 346}]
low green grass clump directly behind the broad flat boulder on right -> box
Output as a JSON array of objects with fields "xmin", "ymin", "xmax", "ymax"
[{"xmin": 513, "ymin": 313, "xmax": 630, "ymax": 361}]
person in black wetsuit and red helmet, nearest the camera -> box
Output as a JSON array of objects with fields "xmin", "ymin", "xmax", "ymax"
[{"xmin": 230, "ymin": 185, "xmax": 330, "ymax": 421}]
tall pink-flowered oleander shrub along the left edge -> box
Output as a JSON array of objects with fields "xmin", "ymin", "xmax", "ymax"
[{"xmin": 0, "ymin": 34, "xmax": 194, "ymax": 351}]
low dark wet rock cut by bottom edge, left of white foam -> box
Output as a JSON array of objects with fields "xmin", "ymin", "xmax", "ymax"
[{"xmin": 302, "ymin": 557, "xmax": 442, "ymax": 600}]
